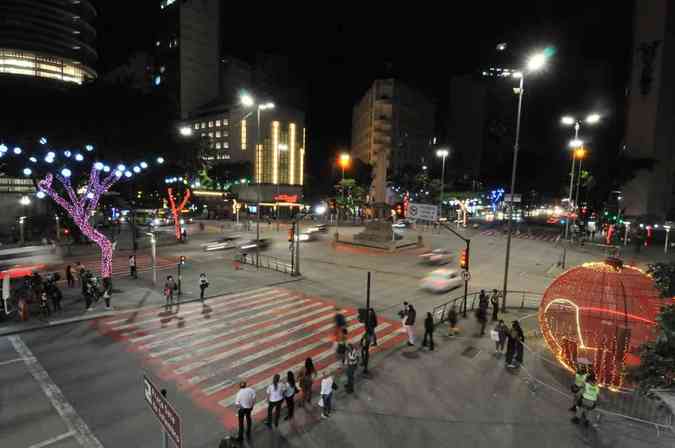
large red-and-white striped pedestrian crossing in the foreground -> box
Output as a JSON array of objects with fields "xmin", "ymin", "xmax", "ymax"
[{"xmin": 94, "ymin": 287, "xmax": 406, "ymax": 428}]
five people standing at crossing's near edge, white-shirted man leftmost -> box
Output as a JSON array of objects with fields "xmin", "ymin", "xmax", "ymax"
[{"xmin": 235, "ymin": 358, "xmax": 337, "ymax": 441}]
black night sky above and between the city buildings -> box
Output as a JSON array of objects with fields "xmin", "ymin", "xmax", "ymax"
[{"xmin": 95, "ymin": 0, "xmax": 632, "ymax": 196}]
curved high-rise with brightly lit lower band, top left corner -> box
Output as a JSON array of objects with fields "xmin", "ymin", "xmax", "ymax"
[{"xmin": 0, "ymin": 0, "xmax": 98, "ymax": 84}]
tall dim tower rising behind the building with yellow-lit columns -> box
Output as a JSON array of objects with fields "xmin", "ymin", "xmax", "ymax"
[{"xmin": 152, "ymin": 0, "xmax": 221, "ymax": 118}]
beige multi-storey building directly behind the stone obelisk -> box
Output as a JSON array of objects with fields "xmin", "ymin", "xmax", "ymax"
[{"xmin": 351, "ymin": 79, "xmax": 435, "ymax": 203}]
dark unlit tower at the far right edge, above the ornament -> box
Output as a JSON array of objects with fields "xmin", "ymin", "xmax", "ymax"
[{"xmin": 622, "ymin": 0, "xmax": 675, "ymax": 218}]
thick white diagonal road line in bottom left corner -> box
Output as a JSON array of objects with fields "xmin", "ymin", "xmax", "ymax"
[{"xmin": 9, "ymin": 336, "xmax": 103, "ymax": 448}]
